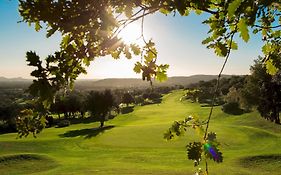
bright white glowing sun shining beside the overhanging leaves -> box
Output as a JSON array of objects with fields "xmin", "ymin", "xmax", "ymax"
[{"xmin": 118, "ymin": 23, "xmax": 142, "ymax": 44}]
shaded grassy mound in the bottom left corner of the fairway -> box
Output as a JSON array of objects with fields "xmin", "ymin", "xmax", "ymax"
[{"xmin": 0, "ymin": 154, "xmax": 58, "ymax": 174}]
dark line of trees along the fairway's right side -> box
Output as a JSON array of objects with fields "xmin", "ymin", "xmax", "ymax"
[{"xmin": 185, "ymin": 58, "xmax": 281, "ymax": 124}]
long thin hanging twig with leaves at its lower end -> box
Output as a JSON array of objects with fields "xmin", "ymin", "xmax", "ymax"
[{"xmin": 164, "ymin": 27, "xmax": 237, "ymax": 175}]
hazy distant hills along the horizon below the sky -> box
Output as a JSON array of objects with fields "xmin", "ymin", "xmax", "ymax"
[{"xmin": 0, "ymin": 75, "xmax": 236, "ymax": 90}]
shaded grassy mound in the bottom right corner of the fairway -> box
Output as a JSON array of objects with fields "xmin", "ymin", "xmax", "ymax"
[{"xmin": 240, "ymin": 154, "xmax": 281, "ymax": 171}]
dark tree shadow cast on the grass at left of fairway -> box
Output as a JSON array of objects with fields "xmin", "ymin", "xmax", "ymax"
[{"xmin": 59, "ymin": 125, "xmax": 115, "ymax": 139}]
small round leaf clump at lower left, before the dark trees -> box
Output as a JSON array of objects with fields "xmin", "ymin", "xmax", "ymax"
[{"xmin": 16, "ymin": 109, "xmax": 47, "ymax": 138}]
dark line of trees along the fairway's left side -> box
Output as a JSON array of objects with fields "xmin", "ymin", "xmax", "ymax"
[{"xmin": 0, "ymin": 87, "xmax": 176, "ymax": 132}]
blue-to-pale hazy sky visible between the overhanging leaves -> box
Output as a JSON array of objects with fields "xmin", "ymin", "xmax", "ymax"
[{"xmin": 0, "ymin": 0, "xmax": 262, "ymax": 78}]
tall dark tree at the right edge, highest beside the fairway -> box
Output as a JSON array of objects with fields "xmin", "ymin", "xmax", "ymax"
[{"xmin": 242, "ymin": 58, "xmax": 281, "ymax": 124}]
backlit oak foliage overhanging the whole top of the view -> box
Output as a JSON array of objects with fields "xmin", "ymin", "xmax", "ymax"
[{"xmin": 19, "ymin": 0, "xmax": 281, "ymax": 105}]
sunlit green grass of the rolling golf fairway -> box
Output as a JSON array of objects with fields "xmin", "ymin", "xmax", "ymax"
[{"xmin": 0, "ymin": 91, "xmax": 281, "ymax": 175}]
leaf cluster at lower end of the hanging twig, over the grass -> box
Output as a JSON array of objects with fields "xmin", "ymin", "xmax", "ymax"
[{"xmin": 164, "ymin": 116, "xmax": 223, "ymax": 173}]
